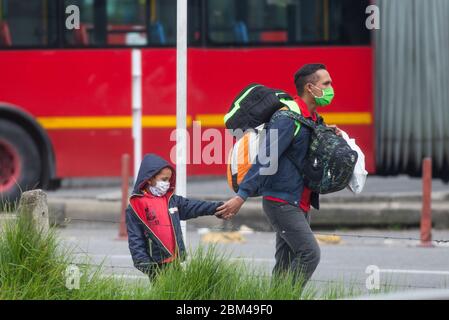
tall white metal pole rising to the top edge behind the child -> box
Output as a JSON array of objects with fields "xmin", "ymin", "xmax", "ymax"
[{"xmin": 176, "ymin": 0, "xmax": 187, "ymax": 243}]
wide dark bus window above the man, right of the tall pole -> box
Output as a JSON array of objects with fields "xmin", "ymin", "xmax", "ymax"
[{"xmin": 207, "ymin": 0, "xmax": 370, "ymax": 45}]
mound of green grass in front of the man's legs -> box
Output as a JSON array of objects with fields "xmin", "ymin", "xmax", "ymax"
[{"xmin": 153, "ymin": 246, "xmax": 313, "ymax": 300}]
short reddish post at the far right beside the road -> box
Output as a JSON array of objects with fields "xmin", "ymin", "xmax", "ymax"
[{"xmin": 421, "ymin": 158, "xmax": 432, "ymax": 247}]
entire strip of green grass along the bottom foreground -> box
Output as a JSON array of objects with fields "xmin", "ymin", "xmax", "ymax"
[{"xmin": 0, "ymin": 215, "xmax": 372, "ymax": 300}]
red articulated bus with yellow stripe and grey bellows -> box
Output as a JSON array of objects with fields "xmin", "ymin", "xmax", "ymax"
[{"xmin": 0, "ymin": 0, "xmax": 449, "ymax": 202}]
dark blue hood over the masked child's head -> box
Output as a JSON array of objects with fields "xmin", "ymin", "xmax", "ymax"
[{"xmin": 133, "ymin": 153, "xmax": 176, "ymax": 194}]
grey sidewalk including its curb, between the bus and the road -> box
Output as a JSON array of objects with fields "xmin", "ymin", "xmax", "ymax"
[{"xmin": 48, "ymin": 176, "xmax": 449, "ymax": 231}]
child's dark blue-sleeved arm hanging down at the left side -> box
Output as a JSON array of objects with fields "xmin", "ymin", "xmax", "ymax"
[{"xmin": 126, "ymin": 207, "xmax": 151, "ymax": 273}]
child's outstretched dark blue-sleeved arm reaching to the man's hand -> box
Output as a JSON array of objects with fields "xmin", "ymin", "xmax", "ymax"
[{"xmin": 173, "ymin": 195, "xmax": 223, "ymax": 220}]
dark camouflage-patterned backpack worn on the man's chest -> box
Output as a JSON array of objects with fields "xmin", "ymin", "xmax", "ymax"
[{"xmin": 271, "ymin": 110, "xmax": 358, "ymax": 194}]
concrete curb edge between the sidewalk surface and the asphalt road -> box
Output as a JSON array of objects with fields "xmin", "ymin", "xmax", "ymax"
[{"xmin": 48, "ymin": 198, "xmax": 449, "ymax": 231}]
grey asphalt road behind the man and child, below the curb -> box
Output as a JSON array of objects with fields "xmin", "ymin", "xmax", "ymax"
[{"xmin": 59, "ymin": 222, "xmax": 449, "ymax": 293}]
